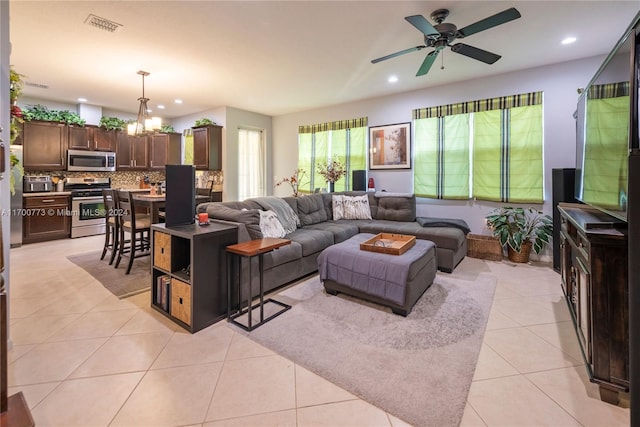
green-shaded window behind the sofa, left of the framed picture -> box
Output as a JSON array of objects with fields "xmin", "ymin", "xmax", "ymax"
[{"xmin": 298, "ymin": 117, "xmax": 367, "ymax": 193}]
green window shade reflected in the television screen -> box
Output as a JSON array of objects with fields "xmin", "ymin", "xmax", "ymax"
[{"xmin": 583, "ymin": 96, "xmax": 629, "ymax": 209}]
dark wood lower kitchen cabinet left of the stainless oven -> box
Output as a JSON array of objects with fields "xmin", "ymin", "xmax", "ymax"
[{"xmin": 20, "ymin": 195, "xmax": 71, "ymax": 243}]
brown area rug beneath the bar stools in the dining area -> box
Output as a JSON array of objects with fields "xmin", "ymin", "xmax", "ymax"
[{"xmin": 67, "ymin": 251, "xmax": 151, "ymax": 298}]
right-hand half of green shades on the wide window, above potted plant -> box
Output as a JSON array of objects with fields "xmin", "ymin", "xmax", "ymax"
[{"xmin": 473, "ymin": 104, "xmax": 543, "ymax": 203}]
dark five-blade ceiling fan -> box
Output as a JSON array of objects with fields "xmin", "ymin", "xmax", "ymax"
[{"xmin": 371, "ymin": 7, "xmax": 521, "ymax": 77}]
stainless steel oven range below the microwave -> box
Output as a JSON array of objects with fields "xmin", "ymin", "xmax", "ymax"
[{"xmin": 65, "ymin": 178, "xmax": 111, "ymax": 238}]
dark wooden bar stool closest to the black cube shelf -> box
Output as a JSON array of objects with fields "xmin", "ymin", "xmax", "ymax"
[{"xmin": 115, "ymin": 191, "xmax": 151, "ymax": 274}]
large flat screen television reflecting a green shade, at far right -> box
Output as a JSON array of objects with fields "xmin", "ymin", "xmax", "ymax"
[{"xmin": 575, "ymin": 14, "xmax": 640, "ymax": 221}]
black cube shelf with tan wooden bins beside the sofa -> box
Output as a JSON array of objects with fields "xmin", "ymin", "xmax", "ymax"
[{"xmin": 151, "ymin": 222, "xmax": 238, "ymax": 333}]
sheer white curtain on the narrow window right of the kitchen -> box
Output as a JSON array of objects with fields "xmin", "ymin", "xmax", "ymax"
[{"xmin": 238, "ymin": 128, "xmax": 266, "ymax": 200}]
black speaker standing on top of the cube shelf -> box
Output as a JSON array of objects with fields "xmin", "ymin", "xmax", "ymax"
[{"xmin": 165, "ymin": 165, "xmax": 196, "ymax": 227}]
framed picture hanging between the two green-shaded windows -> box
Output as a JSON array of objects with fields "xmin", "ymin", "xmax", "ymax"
[{"xmin": 368, "ymin": 123, "xmax": 411, "ymax": 170}]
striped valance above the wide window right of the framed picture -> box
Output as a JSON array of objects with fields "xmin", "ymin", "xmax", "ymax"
[{"xmin": 413, "ymin": 92, "xmax": 542, "ymax": 120}]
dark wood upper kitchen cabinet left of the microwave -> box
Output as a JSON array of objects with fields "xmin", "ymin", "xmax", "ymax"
[{"xmin": 22, "ymin": 121, "xmax": 68, "ymax": 171}]
